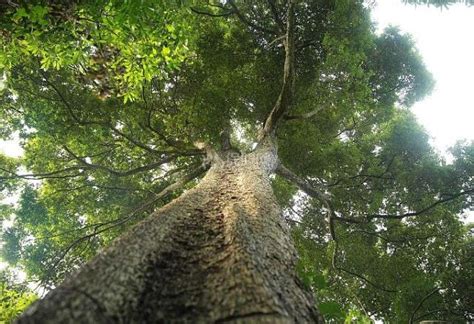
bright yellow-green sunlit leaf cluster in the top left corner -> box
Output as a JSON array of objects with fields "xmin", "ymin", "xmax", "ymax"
[{"xmin": 0, "ymin": 1, "xmax": 194, "ymax": 102}]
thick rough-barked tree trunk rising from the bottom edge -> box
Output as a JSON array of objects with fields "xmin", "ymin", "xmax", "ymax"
[{"xmin": 18, "ymin": 145, "xmax": 322, "ymax": 323}]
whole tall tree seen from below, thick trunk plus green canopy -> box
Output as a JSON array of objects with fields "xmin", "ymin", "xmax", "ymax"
[{"xmin": 0, "ymin": 0, "xmax": 474, "ymax": 323}]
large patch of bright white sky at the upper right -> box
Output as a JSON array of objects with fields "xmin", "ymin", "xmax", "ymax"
[{"xmin": 372, "ymin": 0, "xmax": 474, "ymax": 152}]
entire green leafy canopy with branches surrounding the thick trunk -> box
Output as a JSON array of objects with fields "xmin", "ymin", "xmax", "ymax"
[{"xmin": 0, "ymin": 0, "xmax": 474, "ymax": 322}]
